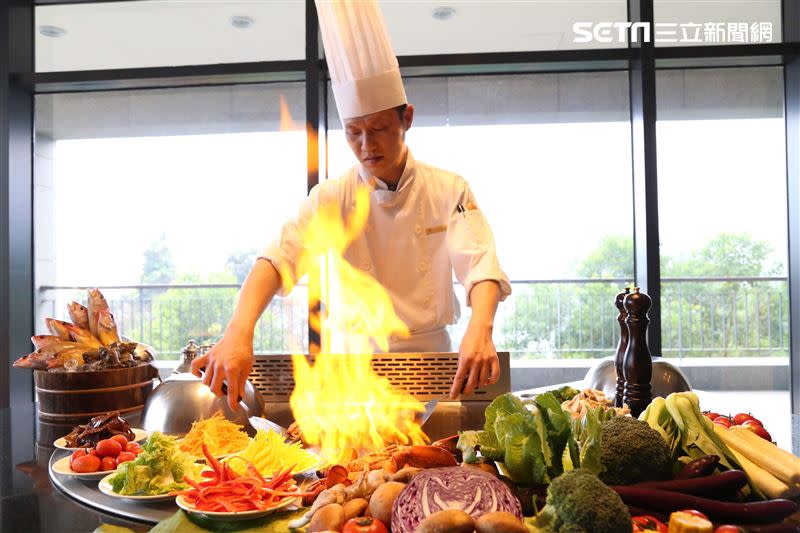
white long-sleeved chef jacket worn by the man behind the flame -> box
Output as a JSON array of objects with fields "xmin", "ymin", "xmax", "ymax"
[{"xmin": 260, "ymin": 153, "xmax": 511, "ymax": 352}]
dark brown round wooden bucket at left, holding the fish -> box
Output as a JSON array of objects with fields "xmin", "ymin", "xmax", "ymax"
[{"xmin": 33, "ymin": 365, "xmax": 158, "ymax": 446}]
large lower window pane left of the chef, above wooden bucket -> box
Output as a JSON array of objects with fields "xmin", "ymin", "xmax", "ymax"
[{"xmin": 34, "ymin": 84, "xmax": 308, "ymax": 357}]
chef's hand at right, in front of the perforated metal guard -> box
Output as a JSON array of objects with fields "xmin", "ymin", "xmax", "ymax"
[{"xmin": 450, "ymin": 324, "xmax": 500, "ymax": 400}]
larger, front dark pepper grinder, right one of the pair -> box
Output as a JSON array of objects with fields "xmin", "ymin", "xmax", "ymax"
[{"xmin": 623, "ymin": 287, "xmax": 653, "ymax": 417}]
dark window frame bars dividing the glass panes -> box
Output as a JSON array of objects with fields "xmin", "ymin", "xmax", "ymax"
[{"xmin": 0, "ymin": 0, "xmax": 800, "ymax": 414}]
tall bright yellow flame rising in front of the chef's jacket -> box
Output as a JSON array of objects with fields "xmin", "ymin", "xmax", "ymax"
[{"xmin": 282, "ymin": 188, "xmax": 428, "ymax": 463}]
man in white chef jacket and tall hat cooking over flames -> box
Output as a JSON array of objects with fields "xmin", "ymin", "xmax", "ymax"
[{"xmin": 192, "ymin": 0, "xmax": 511, "ymax": 409}]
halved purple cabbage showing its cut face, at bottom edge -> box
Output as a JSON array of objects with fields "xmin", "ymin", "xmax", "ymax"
[{"xmin": 392, "ymin": 466, "xmax": 522, "ymax": 533}]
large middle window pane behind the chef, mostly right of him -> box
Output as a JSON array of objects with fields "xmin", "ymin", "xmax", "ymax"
[{"xmin": 329, "ymin": 72, "xmax": 633, "ymax": 359}]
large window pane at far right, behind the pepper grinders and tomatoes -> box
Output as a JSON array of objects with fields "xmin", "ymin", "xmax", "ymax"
[{"xmin": 657, "ymin": 67, "xmax": 789, "ymax": 382}]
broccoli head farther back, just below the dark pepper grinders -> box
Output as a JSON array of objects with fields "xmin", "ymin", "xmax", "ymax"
[{"xmin": 599, "ymin": 416, "xmax": 672, "ymax": 485}]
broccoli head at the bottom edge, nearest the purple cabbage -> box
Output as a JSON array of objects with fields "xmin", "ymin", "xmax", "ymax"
[{"xmin": 533, "ymin": 468, "xmax": 633, "ymax": 533}]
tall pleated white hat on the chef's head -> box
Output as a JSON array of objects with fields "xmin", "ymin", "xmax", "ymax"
[{"xmin": 315, "ymin": 0, "xmax": 408, "ymax": 119}]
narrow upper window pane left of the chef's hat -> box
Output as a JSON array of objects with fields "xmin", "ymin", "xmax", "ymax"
[{"xmin": 36, "ymin": 0, "xmax": 305, "ymax": 72}]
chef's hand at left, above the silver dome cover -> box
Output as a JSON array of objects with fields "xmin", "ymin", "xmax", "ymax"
[{"xmin": 192, "ymin": 332, "xmax": 253, "ymax": 410}]
